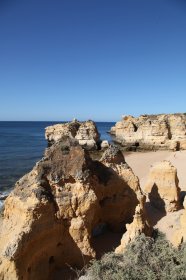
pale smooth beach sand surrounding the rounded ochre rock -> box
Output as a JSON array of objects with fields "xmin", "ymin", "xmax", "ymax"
[{"xmin": 125, "ymin": 151, "xmax": 186, "ymax": 241}]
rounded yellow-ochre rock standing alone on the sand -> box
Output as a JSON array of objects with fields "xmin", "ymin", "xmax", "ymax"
[{"xmin": 144, "ymin": 161, "xmax": 180, "ymax": 212}]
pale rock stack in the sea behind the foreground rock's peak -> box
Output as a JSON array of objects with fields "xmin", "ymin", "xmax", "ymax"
[{"xmin": 45, "ymin": 120, "xmax": 100, "ymax": 149}]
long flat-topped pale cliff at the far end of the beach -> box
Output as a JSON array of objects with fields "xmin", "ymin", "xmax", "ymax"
[{"xmin": 110, "ymin": 114, "xmax": 186, "ymax": 150}]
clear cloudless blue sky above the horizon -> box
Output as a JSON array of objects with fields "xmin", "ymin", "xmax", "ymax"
[{"xmin": 0, "ymin": 0, "xmax": 186, "ymax": 121}]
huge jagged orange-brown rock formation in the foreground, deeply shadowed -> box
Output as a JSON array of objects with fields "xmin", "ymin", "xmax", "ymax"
[{"xmin": 0, "ymin": 143, "xmax": 144, "ymax": 280}]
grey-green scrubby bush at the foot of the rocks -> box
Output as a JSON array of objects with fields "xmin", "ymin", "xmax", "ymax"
[{"xmin": 83, "ymin": 233, "xmax": 186, "ymax": 280}]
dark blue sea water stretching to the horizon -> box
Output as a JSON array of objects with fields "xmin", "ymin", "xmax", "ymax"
[{"xmin": 0, "ymin": 122, "xmax": 114, "ymax": 193}]
